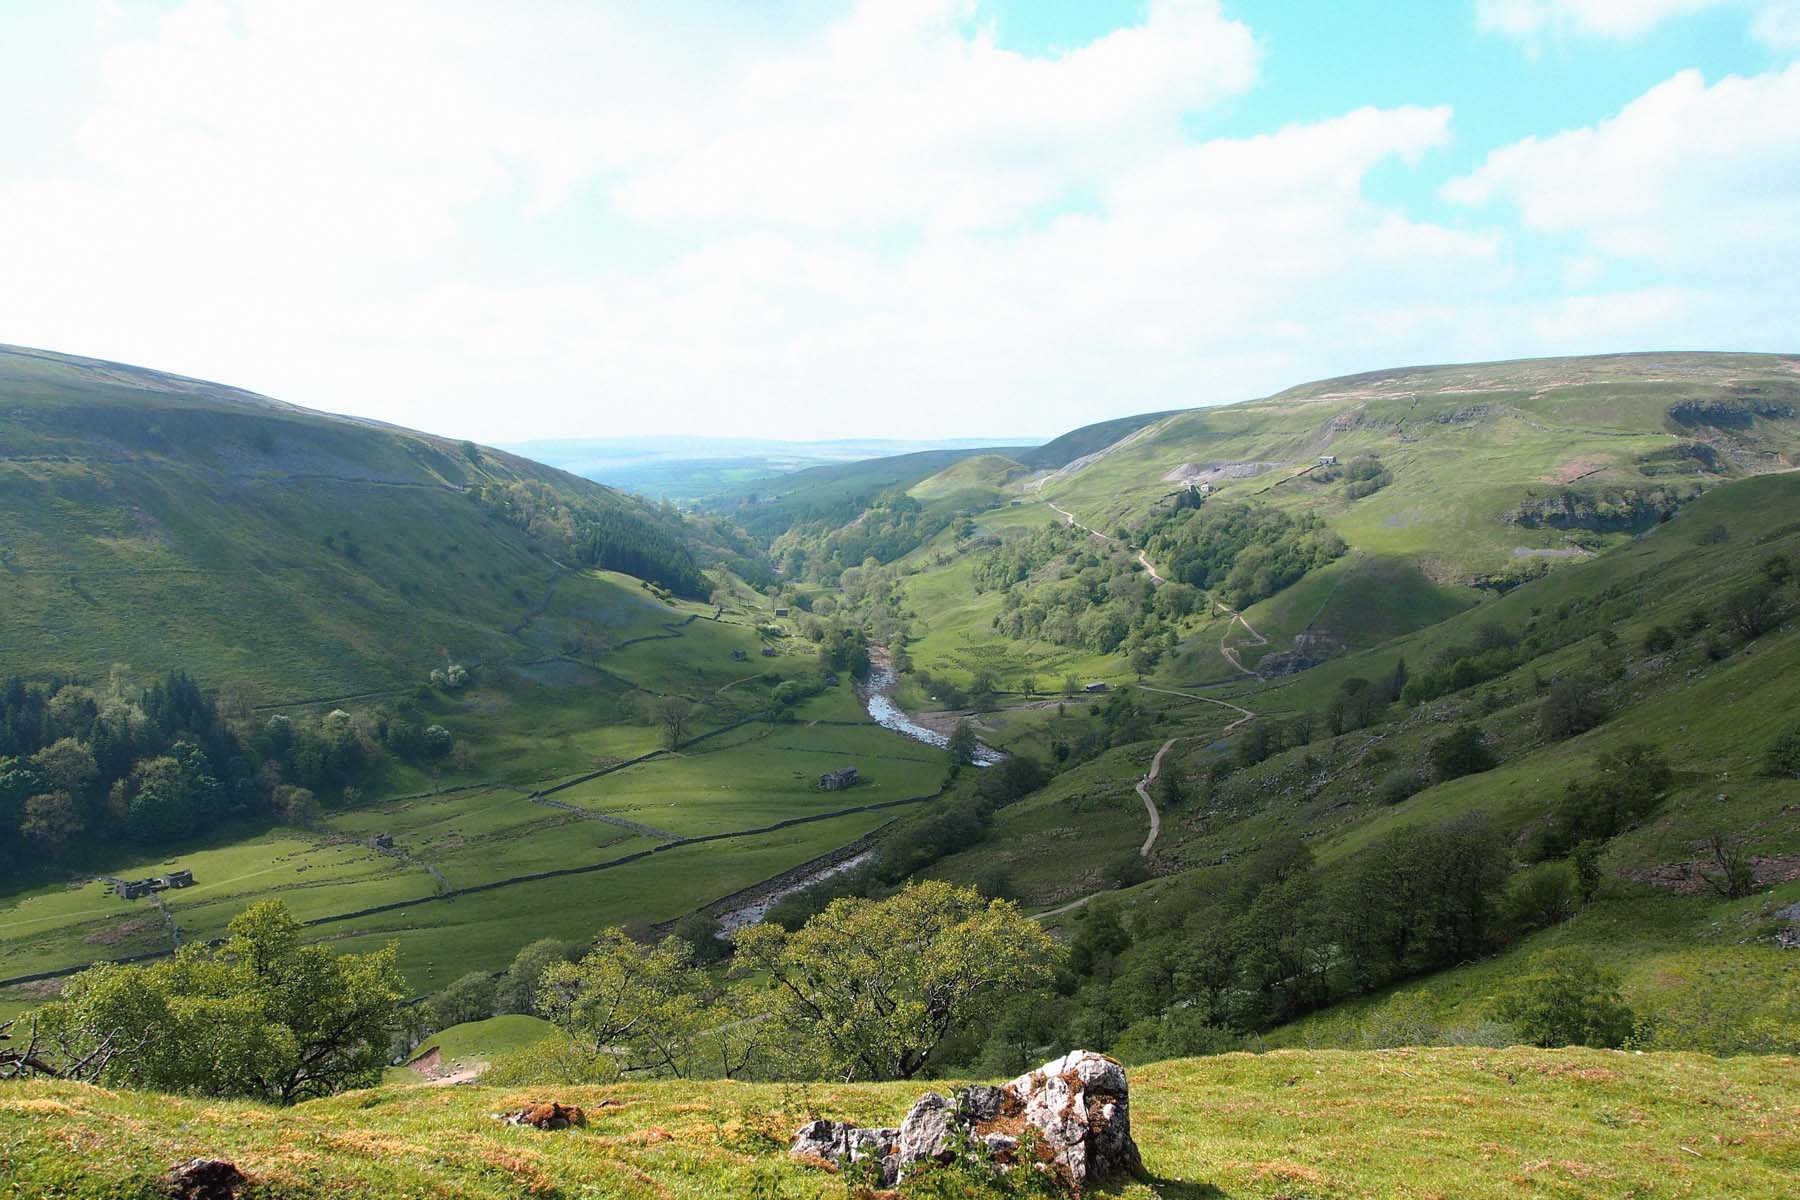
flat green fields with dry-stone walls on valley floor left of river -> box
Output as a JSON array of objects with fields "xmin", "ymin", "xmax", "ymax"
[{"xmin": 0, "ymin": 705, "xmax": 943, "ymax": 1011}]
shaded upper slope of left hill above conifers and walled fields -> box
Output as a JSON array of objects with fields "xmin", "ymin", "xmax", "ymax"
[{"xmin": 0, "ymin": 347, "xmax": 747, "ymax": 703}]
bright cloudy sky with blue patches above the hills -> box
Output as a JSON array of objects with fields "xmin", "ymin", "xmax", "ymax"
[{"xmin": 0, "ymin": 0, "xmax": 1800, "ymax": 443}]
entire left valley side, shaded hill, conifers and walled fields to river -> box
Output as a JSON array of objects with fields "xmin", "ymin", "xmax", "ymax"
[{"xmin": 0, "ymin": 349, "xmax": 943, "ymax": 1015}]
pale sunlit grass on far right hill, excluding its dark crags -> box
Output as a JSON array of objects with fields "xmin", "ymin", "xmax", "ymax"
[{"xmin": 1042, "ymin": 354, "xmax": 1800, "ymax": 646}]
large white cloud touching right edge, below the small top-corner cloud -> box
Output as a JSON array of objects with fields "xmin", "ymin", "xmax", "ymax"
[{"xmin": 1445, "ymin": 65, "xmax": 1800, "ymax": 279}]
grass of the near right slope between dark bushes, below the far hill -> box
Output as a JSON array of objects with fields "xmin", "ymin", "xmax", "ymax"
[{"xmin": 925, "ymin": 475, "xmax": 1800, "ymax": 964}]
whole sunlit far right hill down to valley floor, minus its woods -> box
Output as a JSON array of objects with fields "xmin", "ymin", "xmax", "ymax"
[{"xmin": 802, "ymin": 354, "xmax": 1800, "ymax": 698}]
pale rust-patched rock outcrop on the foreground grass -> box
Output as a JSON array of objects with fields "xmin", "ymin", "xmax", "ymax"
[{"xmin": 790, "ymin": 1051, "xmax": 1143, "ymax": 1191}]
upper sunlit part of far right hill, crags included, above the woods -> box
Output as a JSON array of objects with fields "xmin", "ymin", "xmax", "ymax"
[{"xmin": 1042, "ymin": 354, "xmax": 1800, "ymax": 581}]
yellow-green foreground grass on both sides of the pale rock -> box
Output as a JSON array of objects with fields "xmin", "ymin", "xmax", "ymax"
[{"xmin": 0, "ymin": 1049, "xmax": 1800, "ymax": 1200}]
